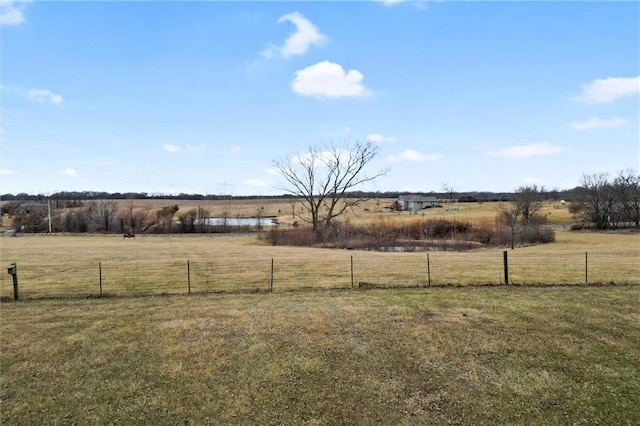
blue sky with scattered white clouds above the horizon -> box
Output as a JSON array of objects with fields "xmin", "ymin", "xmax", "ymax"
[{"xmin": 0, "ymin": 0, "xmax": 640, "ymax": 196}]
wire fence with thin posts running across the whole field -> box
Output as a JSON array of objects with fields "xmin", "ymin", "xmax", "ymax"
[{"xmin": 0, "ymin": 251, "xmax": 640, "ymax": 300}]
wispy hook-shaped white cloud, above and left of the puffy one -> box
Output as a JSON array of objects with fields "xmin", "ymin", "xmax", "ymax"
[{"xmin": 260, "ymin": 12, "xmax": 326, "ymax": 59}]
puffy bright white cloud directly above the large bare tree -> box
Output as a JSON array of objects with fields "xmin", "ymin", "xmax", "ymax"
[{"xmin": 291, "ymin": 61, "xmax": 371, "ymax": 98}]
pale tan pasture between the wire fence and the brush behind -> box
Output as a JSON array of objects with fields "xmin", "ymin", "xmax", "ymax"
[{"xmin": 0, "ymin": 231, "xmax": 640, "ymax": 298}]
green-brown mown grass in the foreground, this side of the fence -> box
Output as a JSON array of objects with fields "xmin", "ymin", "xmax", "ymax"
[{"xmin": 0, "ymin": 286, "xmax": 640, "ymax": 425}]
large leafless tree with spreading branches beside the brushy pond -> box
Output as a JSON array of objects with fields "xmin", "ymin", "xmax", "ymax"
[{"xmin": 274, "ymin": 142, "xmax": 386, "ymax": 231}]
